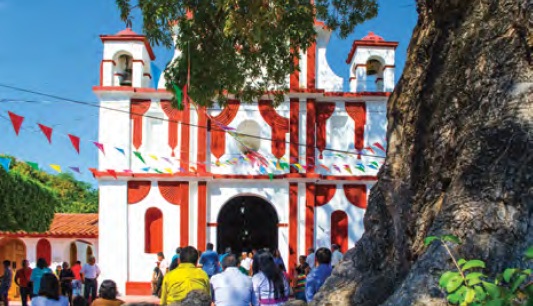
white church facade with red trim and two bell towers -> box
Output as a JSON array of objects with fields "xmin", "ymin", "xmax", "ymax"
[{"xmin": 93, "ymin": 23, "xmax": 398, "ymax": 295}]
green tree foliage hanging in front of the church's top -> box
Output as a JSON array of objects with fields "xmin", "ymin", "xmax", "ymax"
[{"xmin": 116, "ymin": 0, "xmax": 378, "ymax": 105}]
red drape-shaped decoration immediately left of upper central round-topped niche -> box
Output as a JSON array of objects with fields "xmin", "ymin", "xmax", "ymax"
[{"xmin": 211, "ymin": 100, "xmax": 240, "ymax": 159}]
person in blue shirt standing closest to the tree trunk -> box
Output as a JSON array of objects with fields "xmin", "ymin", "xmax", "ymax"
[{"xmin": 305, "ymin": 248, "xmax": 332, "ymax": 303}]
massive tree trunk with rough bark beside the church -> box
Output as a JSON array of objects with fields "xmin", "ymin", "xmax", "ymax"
[{"xmin": 290, "ymin": 0, "xmax": 533, "ymax": 305}]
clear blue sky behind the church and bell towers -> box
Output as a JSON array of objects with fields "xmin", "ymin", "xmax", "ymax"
[{"xmin": 0, "ymin": 0, "xmax": 416, "ymax": 184}]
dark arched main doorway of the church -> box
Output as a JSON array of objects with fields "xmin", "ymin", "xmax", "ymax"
[{"xmin": 217, "ymin": 195, "xmax": 279, "ymax": 254}]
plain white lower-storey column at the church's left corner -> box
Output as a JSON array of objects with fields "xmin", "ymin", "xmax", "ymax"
[{"xmin": 98, "ymin": 180, "xmax": 128, "ymax": 292}]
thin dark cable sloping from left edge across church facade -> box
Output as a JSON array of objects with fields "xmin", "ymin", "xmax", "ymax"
[{"xmin": 0, "ymin": 83, "xmax": 385, "ymax": 158}]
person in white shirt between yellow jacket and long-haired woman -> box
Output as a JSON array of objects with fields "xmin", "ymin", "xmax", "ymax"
[{"xmin": 210, "ymin": 254, "xmax": 259, "ymax": 306}]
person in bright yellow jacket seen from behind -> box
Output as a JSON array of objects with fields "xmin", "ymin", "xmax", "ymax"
[{"xmin": 161, "ymin": 246, "xmax": 211, "ymax": 306}]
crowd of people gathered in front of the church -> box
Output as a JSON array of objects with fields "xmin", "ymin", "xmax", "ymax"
[{"xmin": 0, "ymin": 243, "xmax": 342, "ymax": 306}]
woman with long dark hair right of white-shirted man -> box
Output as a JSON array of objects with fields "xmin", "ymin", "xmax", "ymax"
[{"xmin": 252, "ymin": 252, "xmax": 289, "ymax": 306}]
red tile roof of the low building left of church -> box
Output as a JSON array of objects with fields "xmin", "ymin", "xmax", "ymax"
[{"xmin": 0, "ymin": 214, "xmax": 98, "ymax": 238}]
